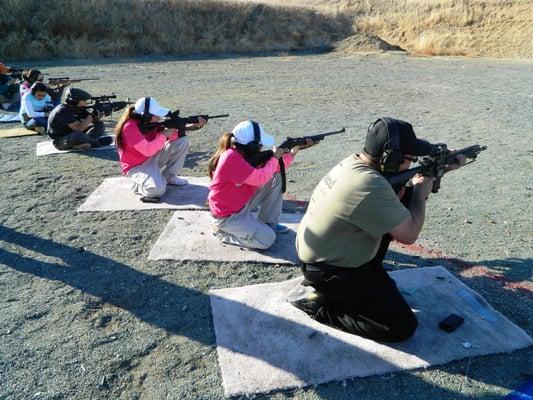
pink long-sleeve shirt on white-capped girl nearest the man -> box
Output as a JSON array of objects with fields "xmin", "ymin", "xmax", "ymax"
[{"xmin": 207, "ymin": 149, "xmax": 294, "ymax": 218}]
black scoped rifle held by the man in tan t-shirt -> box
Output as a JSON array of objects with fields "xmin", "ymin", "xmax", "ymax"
[{"xmin": 386, "ymin": 143, "xmax": 487, "ymax": 193}]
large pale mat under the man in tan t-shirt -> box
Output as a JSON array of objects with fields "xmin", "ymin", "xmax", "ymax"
[{"xmin": 210, "ymin": 267, "xmax": 533, "ymax": 396}]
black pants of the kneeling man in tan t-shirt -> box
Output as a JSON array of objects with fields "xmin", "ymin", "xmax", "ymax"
[{"xmin": 302, "ymin": 187, "xmax": 417, "ymax": 342}]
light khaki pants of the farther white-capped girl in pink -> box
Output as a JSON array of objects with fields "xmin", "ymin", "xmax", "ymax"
[{"xmin": 127, "ymin": 137, "xmax": 189, "ymax": 197}]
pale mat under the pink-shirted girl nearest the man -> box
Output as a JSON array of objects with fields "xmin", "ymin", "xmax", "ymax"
[{"xmin": 148, "ymin": 211, "xmax": 302, "ymax": 264}]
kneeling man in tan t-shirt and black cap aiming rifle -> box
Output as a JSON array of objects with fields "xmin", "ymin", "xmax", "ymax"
[{"xmin": 288, "ymin": 118, "xmax": 464, "ymax": 342}]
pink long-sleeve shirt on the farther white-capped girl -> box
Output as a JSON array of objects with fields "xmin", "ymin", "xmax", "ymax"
[{"xmin": 117, "ymin": 119, "xmax": 178, "ymax": 175}]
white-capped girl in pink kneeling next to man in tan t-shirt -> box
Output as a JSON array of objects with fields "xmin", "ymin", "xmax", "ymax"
[{"xmin": 208, "ymin": 121, "xmax": 308, "ymax": 249}]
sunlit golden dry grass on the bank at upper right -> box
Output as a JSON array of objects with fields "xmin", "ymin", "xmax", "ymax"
[{"xmin": 312, "ymin": 0, "xmax": 533, "ymax": 58}]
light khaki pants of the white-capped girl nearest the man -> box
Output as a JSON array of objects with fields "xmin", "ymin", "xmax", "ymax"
[{"xmin": 214, "ymin": 173, "xmax": 283, "ymax": 250}]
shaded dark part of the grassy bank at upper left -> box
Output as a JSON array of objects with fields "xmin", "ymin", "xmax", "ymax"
[{"xmin": 0, "ymin": 0, "xmax": 351, "ymax": 59}]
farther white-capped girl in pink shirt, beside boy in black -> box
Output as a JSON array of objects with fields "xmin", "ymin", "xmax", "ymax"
[{"xmin": 115, "ymin": 97, "xmax": 206, "ymax": 202}]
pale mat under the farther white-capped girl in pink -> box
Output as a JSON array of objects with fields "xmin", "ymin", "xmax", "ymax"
[{"xmin": 78, "ymin": 176, "xmax": 209, "ymax": 214}]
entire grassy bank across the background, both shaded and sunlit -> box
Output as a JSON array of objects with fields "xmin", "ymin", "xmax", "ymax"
[{"xmin": 0, "ymin": 0, "xmax": 533, "ymax": 59}]
